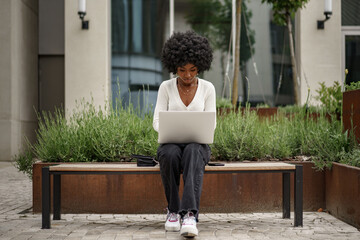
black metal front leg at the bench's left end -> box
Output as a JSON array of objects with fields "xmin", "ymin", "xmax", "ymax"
[{"xmin": 41, "ymin": 167, "xmax": 50, "ymax": 229}]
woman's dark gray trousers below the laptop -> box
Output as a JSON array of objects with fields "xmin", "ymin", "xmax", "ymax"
[{"xmin": 157, "ymin": 143, "xmax": 211, "ymax": 219}]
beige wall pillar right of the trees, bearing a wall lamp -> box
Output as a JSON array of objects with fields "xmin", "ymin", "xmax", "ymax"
[{"xmin": 297, "ymin": 0, "xmax": 342, "ymax": 105}]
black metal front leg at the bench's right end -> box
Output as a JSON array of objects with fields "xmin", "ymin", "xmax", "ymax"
[{"xmin": 294, "ymin": 165, "xmax": 303, "ymax": 227}]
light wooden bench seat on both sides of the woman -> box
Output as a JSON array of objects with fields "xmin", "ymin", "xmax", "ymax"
[{"xmin": 49, "ymin": 162, "xmax": 295, "ymax": 172}]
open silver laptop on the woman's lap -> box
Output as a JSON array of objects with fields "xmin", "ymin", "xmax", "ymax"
[{"xmin": 158, "ymin": 111, "xmax": 216, "ymax": 144}]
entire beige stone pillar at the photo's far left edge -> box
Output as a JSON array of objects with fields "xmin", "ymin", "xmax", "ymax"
[{"xmin": 0, "ymin": 0, "xmax": 38, "ymax": 161}]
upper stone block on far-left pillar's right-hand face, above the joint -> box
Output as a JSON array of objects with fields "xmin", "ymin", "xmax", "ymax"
[{"xmin": 11, "ymin": 0, "xmax": 38, "ymax": 123}]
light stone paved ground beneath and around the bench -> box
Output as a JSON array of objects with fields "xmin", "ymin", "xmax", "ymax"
[{"xmin": 0, "ymin": 162, "xmax": 360, "ymax": 240}]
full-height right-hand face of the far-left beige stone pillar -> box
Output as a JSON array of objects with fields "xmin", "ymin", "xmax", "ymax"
[{"xmin": 11, "ymin": 0, "xmax": 38, "ymax": 156}]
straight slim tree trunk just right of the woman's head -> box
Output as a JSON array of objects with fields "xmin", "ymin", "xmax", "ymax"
[{"xmin": 232, "ymin": 0, "xmax": 242, "ymax": 107}]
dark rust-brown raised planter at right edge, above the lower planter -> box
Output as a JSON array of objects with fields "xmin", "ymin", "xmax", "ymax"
[{"xmin": 343, "ymin": 89, "xmax": 360, "ymax": 143}]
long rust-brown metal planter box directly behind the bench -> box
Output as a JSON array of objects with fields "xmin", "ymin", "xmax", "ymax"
[{"xmin": 33, "ymin": 162, "xmax": 325, "ymax": 214}]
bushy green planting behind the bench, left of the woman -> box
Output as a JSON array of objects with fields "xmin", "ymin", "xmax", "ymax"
[{"xmin": 15, "ymin": 98, "xmax": 158, "ymax": 171}]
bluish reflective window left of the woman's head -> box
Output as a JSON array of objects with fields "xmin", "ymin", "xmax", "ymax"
[{"xmin": 111, "ymin": 0, "xmax": 167, "ymax": 109}]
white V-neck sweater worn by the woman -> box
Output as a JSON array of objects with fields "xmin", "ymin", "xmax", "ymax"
[{"xmin": 153, "ymin": 78, "xmax": 216, "ymax": 132}]
